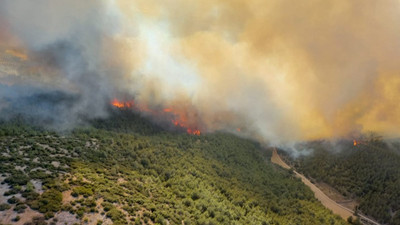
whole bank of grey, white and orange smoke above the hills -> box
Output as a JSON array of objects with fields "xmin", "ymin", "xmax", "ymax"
[{"xmin": 0, "ymin": 0, "xmax": 400, "ymax": 144}]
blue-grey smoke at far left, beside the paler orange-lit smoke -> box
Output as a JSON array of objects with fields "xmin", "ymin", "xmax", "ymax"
[{"xmin": 0, "ymin": 0, "xmax": 123, "ymax": 127}]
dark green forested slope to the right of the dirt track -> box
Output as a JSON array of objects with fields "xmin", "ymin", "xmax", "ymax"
[{"xmin": 282, "ymin": 136, "xmax": 400, "ymax": 225}]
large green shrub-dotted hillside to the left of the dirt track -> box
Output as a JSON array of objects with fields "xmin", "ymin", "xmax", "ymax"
[{"xmin": 0, "ymin": 111, "xmax": 346, "ymax": 224}]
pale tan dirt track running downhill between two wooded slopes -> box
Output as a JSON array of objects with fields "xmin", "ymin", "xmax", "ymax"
[{"xmin": 271, "ymin": 149, "xmax": 380, "ymax": 225}]
